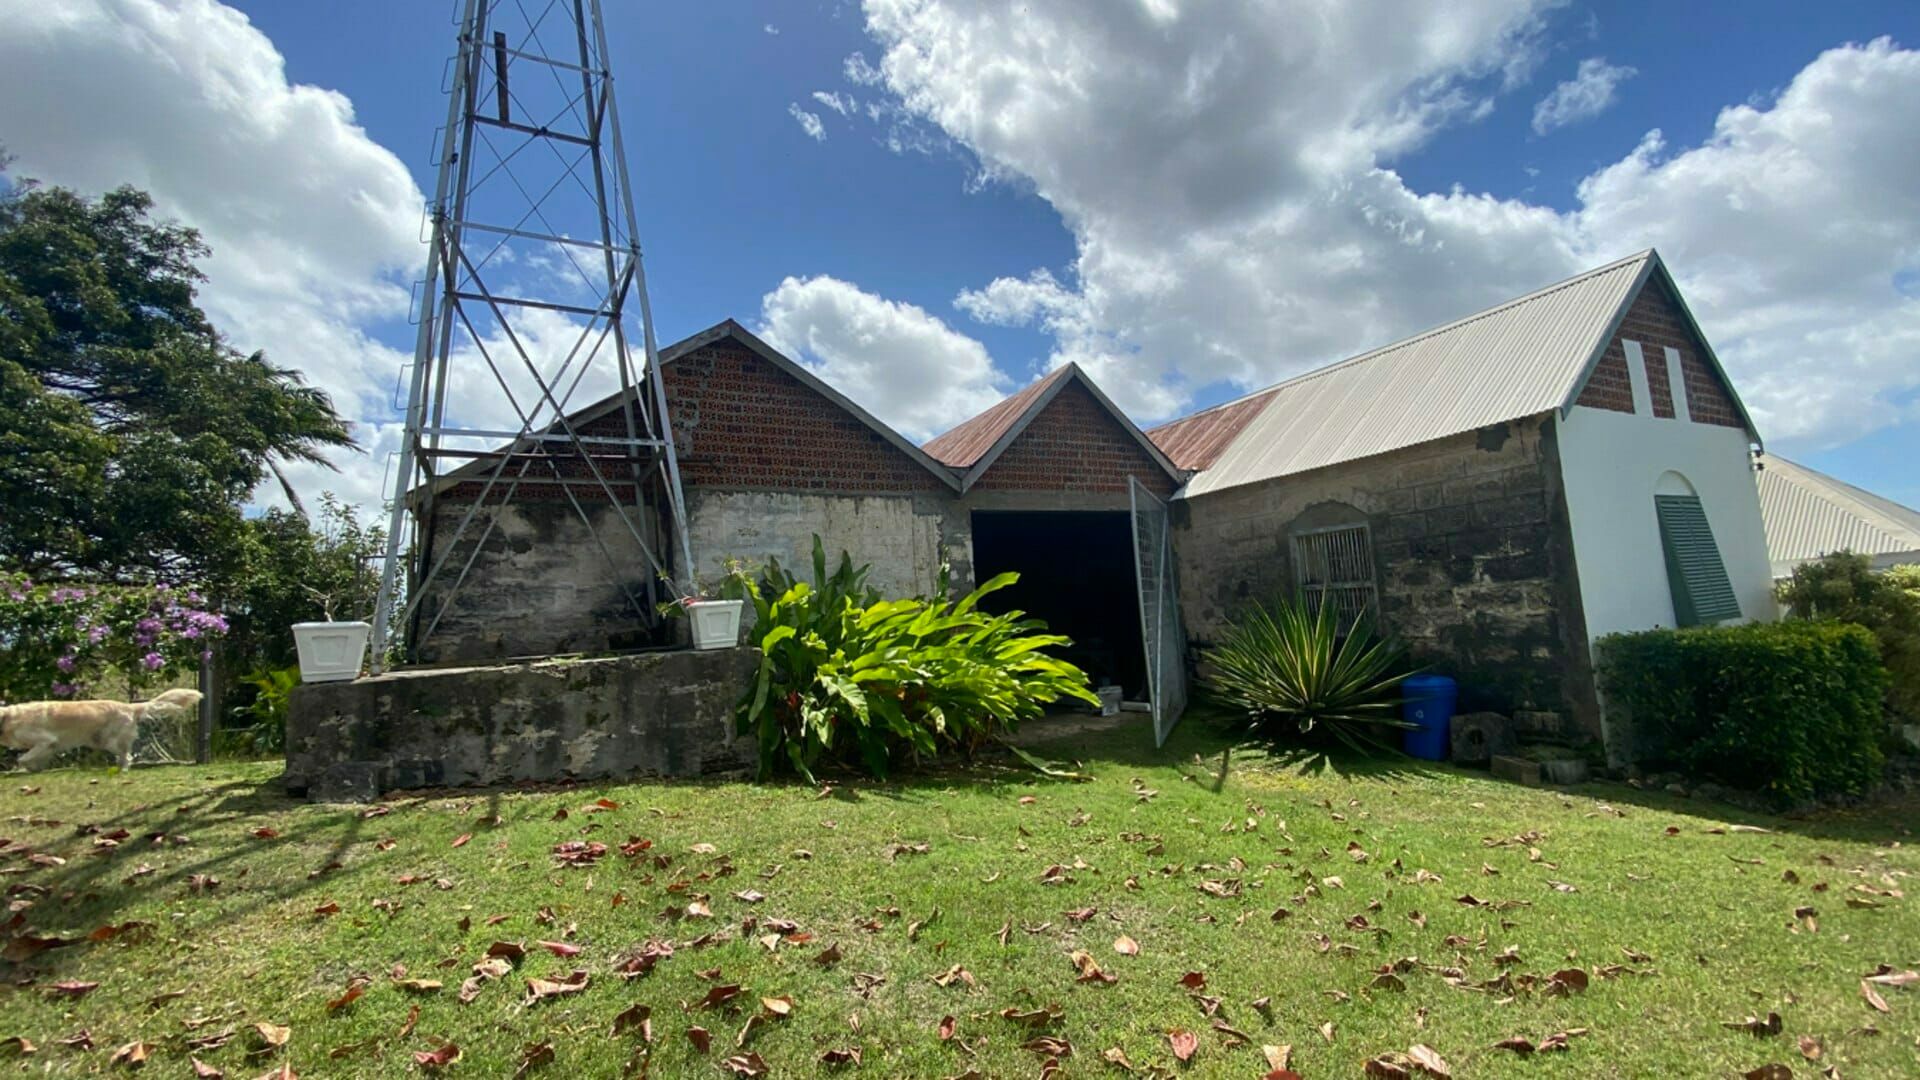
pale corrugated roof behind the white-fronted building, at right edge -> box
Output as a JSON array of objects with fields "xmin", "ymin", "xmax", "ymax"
[{"xmin": 1759, "ymin": 454, "xmax": 1920, "ymax": 575}]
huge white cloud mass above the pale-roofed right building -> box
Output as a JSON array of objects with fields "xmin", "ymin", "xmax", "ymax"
[{"xmin": 847, "ymin": 0, "xmax": 1920, "ymax": 440}]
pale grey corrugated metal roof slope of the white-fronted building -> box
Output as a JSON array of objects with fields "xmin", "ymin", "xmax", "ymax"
[{"xmin": 1185, "ymin": 250, "xmax": 1659, "ymax": 496}]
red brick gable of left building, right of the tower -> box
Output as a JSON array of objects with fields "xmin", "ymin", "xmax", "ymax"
[{"xmin": 645, "ymin": 340, "xmax": 945, "ymax": 492}]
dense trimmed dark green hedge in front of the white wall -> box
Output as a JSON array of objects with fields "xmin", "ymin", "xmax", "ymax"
[{"xmin": 1599, "ymin": 621, "xmax": 1887, "ymax": 801}]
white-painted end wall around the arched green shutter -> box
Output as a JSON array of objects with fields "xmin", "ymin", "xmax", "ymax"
[{"xmin": 1559, "ymin": 405, "xmax": 1776, "ymax": 642}]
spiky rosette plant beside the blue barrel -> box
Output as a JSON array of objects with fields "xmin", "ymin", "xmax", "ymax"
[{"xmin": 1202, "ymin": 596, "xmax": 1413, "ymax": 749}]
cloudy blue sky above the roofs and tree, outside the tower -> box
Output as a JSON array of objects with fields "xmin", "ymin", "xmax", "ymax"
[{"xmin": 0, "ymin": 0, "xmax": 1920, "ymax": 503}]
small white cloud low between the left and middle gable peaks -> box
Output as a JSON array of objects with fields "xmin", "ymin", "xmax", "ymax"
[{"xmin": 756, "ymin": 275, "xmax": 1010, "ymax": 442}]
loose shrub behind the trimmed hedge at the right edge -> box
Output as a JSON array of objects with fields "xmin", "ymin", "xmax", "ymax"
[{"xmin": 1780, "ymin": 552, "xmax": 1920, "ymax": 721}]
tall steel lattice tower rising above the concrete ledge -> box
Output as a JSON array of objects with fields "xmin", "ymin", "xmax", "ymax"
[{"xmin": 372, "ymin": 0, "xmax": 693, "ymax": 671}]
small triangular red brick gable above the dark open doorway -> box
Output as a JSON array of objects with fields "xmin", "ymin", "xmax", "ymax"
[{"xmin": 973, "ymin": 382, "xmax": 1173, "ymax": 496}]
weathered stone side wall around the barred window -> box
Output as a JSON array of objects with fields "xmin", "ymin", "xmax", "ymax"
[{"xmin": 1175, "ymin": 415, "xmax": 1599, "ymax": 738}]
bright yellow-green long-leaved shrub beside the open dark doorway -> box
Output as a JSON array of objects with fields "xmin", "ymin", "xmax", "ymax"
[{"xmin": 735, "ymin": 536, "xmax": 1098, "ymax": 780}]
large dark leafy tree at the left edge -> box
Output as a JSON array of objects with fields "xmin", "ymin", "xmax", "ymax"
[{"xmin": 0, "ymin": 181, "xmax": 353, "ymax": 598}]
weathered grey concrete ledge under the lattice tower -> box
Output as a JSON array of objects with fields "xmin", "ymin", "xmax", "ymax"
[{"xmin": 284, "ymin": 648, "xmax": 760, "ymax": 801}]
